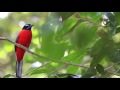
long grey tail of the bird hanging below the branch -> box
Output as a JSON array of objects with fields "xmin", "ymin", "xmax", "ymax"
[{"xmin": 16, "ymin": 60, "xmax": 23, "ymax": 78}]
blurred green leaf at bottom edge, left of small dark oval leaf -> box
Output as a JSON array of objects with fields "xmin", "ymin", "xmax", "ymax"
[{"xmin": 82, "ymin": 67, "xmax": 96, "ymax": 78}]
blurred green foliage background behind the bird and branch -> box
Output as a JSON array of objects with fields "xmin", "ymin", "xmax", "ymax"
[{"xmin": 0, "ymin": 12, "xmax": 120, "ymax": 78}]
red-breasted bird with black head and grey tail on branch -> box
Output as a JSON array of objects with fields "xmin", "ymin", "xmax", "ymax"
[{"xmin": 15, "ymin": 24, "xmax": 33, "ymax": 78}]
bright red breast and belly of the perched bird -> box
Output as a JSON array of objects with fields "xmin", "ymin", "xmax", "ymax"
[{"xmin": 15, "ymin": 30, "xmax": 32, "ymax": 62}]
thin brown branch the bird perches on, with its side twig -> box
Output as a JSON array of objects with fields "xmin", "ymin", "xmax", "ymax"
[{"xmin": 0, "ymin": 37, "xmax": 120, "ymax": 76}]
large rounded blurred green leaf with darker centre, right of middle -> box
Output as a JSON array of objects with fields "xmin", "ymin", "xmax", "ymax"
[{"xmin": 70, "ymin": 22, "xmax": 97, "ymax": 48}]
